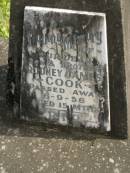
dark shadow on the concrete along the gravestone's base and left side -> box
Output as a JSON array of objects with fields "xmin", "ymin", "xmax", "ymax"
[{"xmin": 0, "ymin": 65, "xmax": 109, "ymax": 141}]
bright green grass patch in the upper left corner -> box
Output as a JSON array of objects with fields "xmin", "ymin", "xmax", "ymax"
[{"xmin": 0, "ymin": 0, "xmax": 10, "ymax": 38}]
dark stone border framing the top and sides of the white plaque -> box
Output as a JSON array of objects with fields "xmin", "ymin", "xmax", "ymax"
[{"xmin": 7, "ymin": 0, "xmax": 127, "ymax": 138}]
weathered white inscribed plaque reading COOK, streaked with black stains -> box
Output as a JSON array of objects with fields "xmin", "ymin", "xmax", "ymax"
[{"xmin": 20, "ymin": 7, "xmax": 110, "ymax": 130}]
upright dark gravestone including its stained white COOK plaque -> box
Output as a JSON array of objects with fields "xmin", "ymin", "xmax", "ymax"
[{"xmin": 7, "ymin": 0, "xmax": 127, "ymax": 138}]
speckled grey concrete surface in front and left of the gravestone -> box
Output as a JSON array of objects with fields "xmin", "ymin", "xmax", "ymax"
[{"xmin": 0, "ymin": 39, "xmax": 130, "ymax": 173}]
